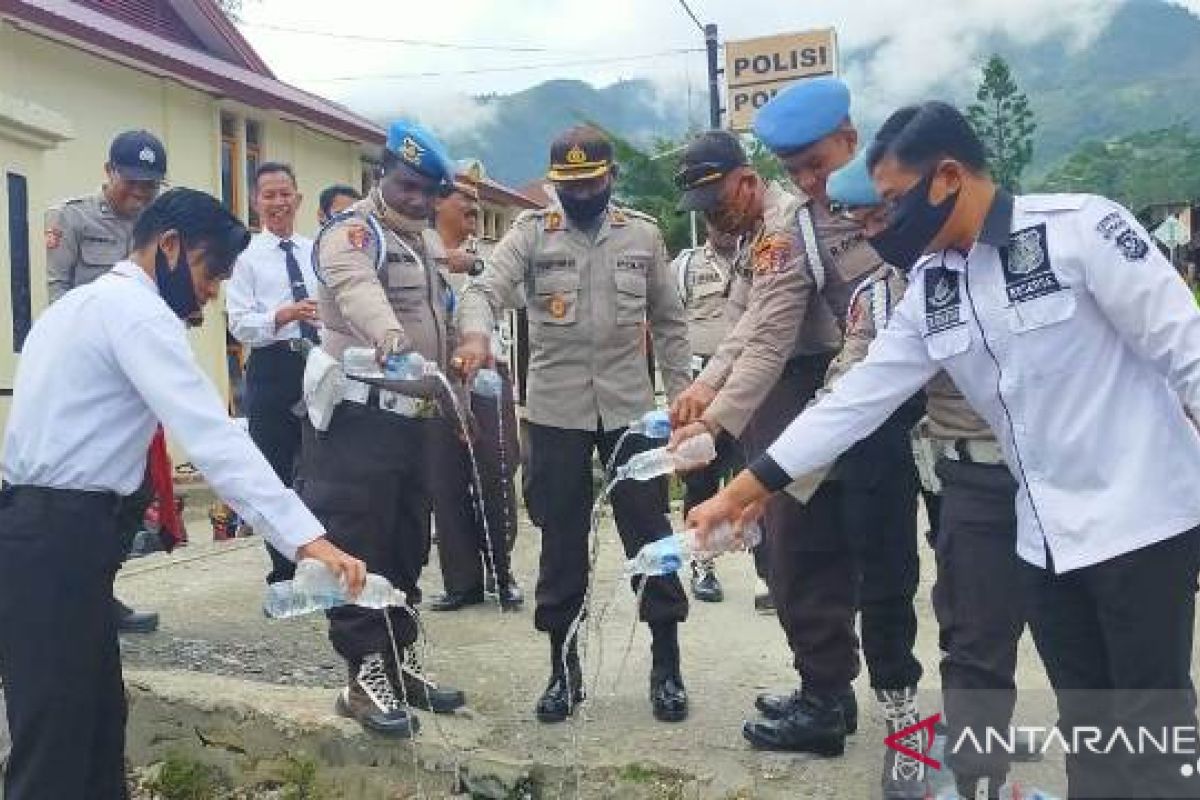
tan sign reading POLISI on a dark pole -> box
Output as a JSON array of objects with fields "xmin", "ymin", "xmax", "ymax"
[{"xmin": 725, "ymin": 28, "xmax": 838, "ymax": 131}]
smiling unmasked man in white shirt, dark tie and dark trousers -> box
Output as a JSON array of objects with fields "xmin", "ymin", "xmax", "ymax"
[{"xmin": 226, "ymin": 162, "xmax": 319, "ymax": 583}]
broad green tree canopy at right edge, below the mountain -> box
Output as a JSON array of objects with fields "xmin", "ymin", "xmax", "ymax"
[{"xmin": 1038, "ymin": 125, "xmax": 1200, "ymax": 212}]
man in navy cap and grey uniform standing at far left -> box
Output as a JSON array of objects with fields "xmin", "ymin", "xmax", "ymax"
[{"xmin": 46, "ymin": 131, "xmax": 175, "ymax": 633}]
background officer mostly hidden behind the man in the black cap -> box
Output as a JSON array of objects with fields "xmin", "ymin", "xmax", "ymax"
[{"xmin": 671, "ymin": 229, "xmax": 774, "ymax": 604}]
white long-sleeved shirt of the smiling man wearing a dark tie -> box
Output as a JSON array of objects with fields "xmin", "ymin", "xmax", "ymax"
[{"xmin": 226, "ymin": 230, "xmax": 317, "ymax": 348}]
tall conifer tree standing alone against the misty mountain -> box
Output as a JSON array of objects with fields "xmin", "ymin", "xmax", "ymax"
[{"xmin": 967, "ymin": 55, "xmax": 1037, "ymax": 192}]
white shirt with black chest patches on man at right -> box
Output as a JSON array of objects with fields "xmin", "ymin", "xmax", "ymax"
[{"xmin": 756, "ymin": 194, "xmax": 1200, "ymax": 572}]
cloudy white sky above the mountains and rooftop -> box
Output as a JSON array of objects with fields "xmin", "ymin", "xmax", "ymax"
[{"xmin": 234, "ymin": 0, "xmax": 1200, "ymax": 128}]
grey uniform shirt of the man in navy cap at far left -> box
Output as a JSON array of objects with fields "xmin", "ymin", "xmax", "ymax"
[{"xmin": 46, "ymin": 192, "xmax": 137, "ymax": 302}]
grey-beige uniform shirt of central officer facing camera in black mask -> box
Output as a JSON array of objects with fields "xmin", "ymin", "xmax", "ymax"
[{"xmin": 458, "ymin": 206, "xmax": 691, "ymax": 431}]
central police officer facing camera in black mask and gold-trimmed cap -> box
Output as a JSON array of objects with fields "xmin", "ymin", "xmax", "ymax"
[{"xmin": 460, "ymin": 127, "xmax": 689, "ymax": 722}]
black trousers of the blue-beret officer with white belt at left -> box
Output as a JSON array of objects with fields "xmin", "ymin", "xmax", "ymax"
[{"xmin": 298, "ymin": 402, "xmax": 428, "ymax": 672}]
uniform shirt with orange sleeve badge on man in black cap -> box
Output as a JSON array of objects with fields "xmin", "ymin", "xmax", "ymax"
[{"xmin": 697, "ymin": 182, "xmax": 841, "ymax": 437}]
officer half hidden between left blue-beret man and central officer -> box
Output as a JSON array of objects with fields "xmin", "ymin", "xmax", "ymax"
[{"xmin": 430, "ymin": 176, "xmax": 524, "ymax": 612}]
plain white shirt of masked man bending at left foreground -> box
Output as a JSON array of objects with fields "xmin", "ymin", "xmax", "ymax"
[{"xmin": 0, "ymin": 261, "xmax": 323, "ymax": 558}]
